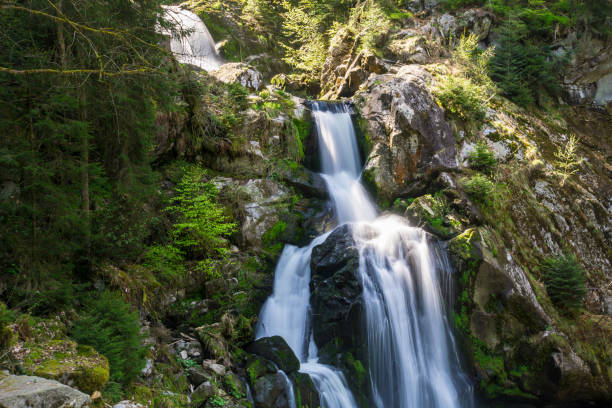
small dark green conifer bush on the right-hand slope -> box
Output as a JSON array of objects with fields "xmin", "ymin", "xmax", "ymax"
[{"xmin": 540, "ymin": 254, "xmax": 586, "ymax": 315}]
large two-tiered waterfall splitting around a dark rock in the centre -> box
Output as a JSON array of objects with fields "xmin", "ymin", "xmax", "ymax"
[{"xmin": 256, "ymin": 102, "xmax": 473, "ymax": 408}]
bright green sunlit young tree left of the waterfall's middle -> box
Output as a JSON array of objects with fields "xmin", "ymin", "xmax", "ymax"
[{"xmin": 166, "ymin": 166, "xmax": 236, "ymax": 256}]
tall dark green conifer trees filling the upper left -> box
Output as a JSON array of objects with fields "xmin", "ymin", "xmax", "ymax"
[{"xmin": 0, "ymin": 0, "xmax": 175, "ymax": 312}]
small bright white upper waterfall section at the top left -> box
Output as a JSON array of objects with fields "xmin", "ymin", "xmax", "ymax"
[{"xmin": 164, "ymin": 6, "xmax": 223, "ymax": 71}]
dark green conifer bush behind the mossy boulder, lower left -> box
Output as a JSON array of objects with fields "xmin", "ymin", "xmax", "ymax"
[{"xmin": 70, "ymin": 291, "xmax": 146, "ymax": 384}]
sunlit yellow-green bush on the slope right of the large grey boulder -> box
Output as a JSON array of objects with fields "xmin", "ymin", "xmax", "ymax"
[{"xmin": 436, "ymin": 76, "xmax": 487, "ymax": 122}]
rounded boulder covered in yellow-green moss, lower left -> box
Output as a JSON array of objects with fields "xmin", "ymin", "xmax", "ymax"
[{"xmin": 24, "ymin": 340, "xmax": 110, "ymax": 394}]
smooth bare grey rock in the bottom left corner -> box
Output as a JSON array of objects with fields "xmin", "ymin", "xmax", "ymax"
[{"xmin": 0, "ymin": 374, "xmax": 91, "ymax": 408}]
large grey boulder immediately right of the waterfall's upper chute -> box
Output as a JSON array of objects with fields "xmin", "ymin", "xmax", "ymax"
[{"xmin": 355, "ymin": 65, "xmax": 458, "ymax": 199}]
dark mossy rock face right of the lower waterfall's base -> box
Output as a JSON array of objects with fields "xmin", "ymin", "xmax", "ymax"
[{"xmin": 448, "ymin": 229, "xmax": 611, "ymax": 403}]
